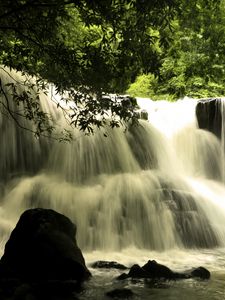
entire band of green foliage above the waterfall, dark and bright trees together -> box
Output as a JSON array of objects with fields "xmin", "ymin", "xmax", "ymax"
[{"xmin": 0, "ymin": 0, "xmax": 225, "ymax": 135}]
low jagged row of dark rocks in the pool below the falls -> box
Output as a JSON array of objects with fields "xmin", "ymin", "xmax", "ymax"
[{"xmin": 117, "ymin": 260, "xmax": 210, "ymax": 280}]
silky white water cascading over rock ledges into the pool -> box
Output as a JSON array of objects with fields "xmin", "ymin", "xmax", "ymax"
[{"xmin": 0, "ymin": 68, "xmax": 225, "ymax": 300}]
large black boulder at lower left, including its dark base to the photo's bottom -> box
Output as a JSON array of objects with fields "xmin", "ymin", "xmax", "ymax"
[{"xmin": 0, "ymin": 208, "xmax": 91, "ymax": 299}]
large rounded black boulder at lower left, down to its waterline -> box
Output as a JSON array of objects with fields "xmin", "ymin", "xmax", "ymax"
[{"xmin": 0, "ymin": 208, "xmax": 91, "ymax": 282}]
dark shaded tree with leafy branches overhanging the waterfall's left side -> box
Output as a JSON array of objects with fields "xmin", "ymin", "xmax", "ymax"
[{"xmin": 0, "ymin": 0, "xmax": 180, "ymax": 137}]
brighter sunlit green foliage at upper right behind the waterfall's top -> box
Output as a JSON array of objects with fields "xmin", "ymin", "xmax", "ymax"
[{"xmin": 128, "ymin": 1, "xmax": 225, "ymax": 100}]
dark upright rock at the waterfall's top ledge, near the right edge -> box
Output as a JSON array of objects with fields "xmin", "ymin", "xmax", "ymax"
[{"xmin": 196, "ymin": 98, "xmax": 223, "ymax": 139}]
